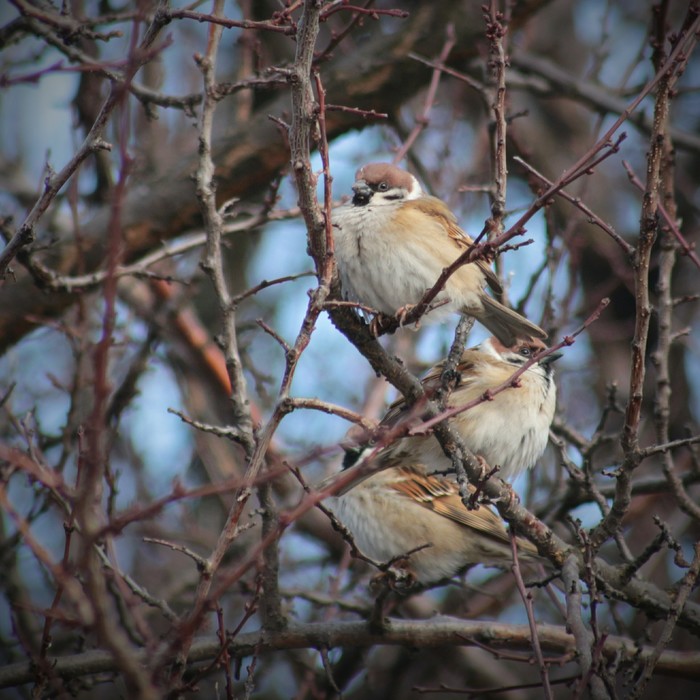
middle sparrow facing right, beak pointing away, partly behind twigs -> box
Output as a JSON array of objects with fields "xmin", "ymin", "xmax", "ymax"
[{"xmin": 345, "ymin": 337, "xmax": 562, "ymax": 481}]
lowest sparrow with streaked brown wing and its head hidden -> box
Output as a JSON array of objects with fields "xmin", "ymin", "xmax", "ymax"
[{"xmin": 331, "ymin": 461, "xmax": 537, "ymax": 585}]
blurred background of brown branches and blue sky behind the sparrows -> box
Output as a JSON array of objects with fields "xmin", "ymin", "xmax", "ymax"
[{"xmin": 0, "ymin": 0, "xmax": 700, "ymax": 698}]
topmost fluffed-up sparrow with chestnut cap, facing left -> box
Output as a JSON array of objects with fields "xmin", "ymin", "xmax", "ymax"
[{"xmin": 333, "ymin": 163, "xmax": 547, "ymax": 346}]
